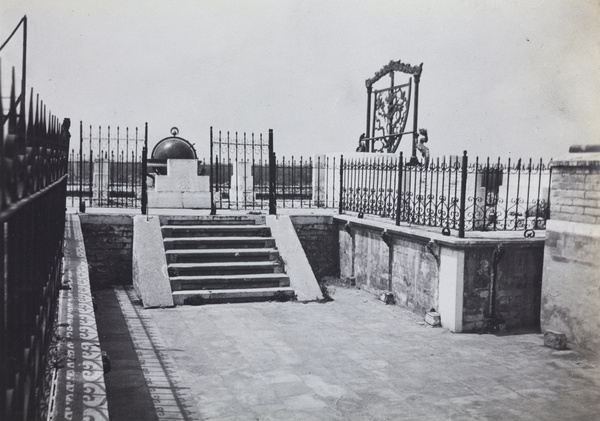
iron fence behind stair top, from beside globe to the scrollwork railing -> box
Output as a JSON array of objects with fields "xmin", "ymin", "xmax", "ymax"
[{"xmin": 208, "ymin": 127, "xmax": 339, "ymax": 213}]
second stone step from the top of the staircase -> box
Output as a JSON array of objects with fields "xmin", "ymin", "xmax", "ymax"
[{"xmin": 161, "ymin": 225, "xmax": 271, "ymax": 238}]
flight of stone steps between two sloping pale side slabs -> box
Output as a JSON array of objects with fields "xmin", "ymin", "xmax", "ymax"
[{"xmin": 161, "ymin": 217, "xmax": 295, "ymax": 305}]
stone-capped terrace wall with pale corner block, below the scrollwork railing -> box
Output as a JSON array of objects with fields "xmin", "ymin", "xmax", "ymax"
[{"xmin": 334, "ymin": 215, "xmax": 544, "ymax": 332}]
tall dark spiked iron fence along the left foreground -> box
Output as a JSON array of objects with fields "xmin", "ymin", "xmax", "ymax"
[{"xmin": 0, "ymin": 70, "xmax": 70, "ymax": 420}]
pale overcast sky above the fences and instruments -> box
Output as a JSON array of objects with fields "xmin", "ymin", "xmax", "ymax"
[{"xmin": 0, "ymin": 0, "xmax": 600, "ymax": 158}]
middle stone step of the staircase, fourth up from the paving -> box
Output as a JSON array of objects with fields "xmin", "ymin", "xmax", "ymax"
[{"xmin": 166, "ymin": 248, "xmax": 279, "ymax": 263}]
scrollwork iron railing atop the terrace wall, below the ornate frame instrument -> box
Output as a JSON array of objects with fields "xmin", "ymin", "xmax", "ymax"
[{"xmin": 339, "ymin": 152, "xmax": 551, "ymax": 237}]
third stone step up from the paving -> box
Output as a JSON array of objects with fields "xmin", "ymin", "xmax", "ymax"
[{"xmin": 168, "ymin": 260, "xmax": 283, "ymax": 276}]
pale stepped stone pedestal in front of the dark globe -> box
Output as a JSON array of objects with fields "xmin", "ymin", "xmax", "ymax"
[{"xmin": 148, "ymin": 159, "xmax": 210, "ymax": 209}]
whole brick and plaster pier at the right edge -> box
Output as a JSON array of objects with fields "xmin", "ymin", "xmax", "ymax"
[{"xmin": 540, "ymin": 148, "xmax": 600, "ymax": 351}]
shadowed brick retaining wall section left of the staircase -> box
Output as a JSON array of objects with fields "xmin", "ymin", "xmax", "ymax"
[{"xmin": 79, "ymin": 214, "xmax": 133, "ymax": 290}]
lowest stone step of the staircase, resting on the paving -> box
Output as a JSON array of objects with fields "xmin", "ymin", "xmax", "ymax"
[{"xmin": 173, "ymin": 287, "xmax": 295, "ymax": 305}]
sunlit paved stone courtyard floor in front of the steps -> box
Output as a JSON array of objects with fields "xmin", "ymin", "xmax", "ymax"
[{"xmin": 116, "ymin": 288, "xmax": 600, "ymax": 421}]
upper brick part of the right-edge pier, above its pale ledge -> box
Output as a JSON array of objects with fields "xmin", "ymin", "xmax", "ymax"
[{"xmin": 550, "ymin": 166, "xmax": 600, "ymax": 224}]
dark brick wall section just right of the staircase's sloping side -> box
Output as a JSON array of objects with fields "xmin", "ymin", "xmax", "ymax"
[{"xmin": 290, "ymin": 215, "xmax": 340, "ymax": 282}]
